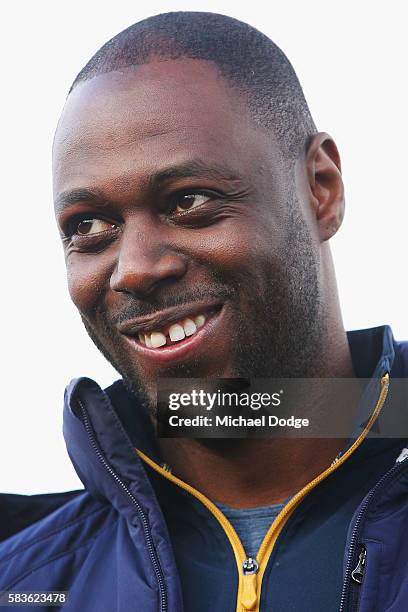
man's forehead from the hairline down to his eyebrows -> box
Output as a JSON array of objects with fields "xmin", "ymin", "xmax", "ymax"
[{"xmin": 54, "ymin": 59, "xmax": 278, "ymax": 196}]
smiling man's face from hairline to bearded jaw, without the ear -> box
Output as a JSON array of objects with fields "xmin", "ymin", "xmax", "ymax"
[{"xmin": 54, "ymin": 59, "xmax": 321, "ymax": 402}]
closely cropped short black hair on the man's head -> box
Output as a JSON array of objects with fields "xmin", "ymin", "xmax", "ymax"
[{"xmin": 69, "ymin": 11, "xmax": 316, "ymax": 160}]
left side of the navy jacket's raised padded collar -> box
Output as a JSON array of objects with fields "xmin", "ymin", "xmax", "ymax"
[{"xmin": 63, "ymin": 378, "xmax": 159, "ymax": 519}]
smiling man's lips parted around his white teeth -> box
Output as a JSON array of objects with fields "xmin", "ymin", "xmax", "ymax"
[{"xmin": 119, "ymin": 303, "xmax": 223, "ymax": 365}]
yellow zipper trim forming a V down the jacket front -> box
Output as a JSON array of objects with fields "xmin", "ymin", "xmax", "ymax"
[{"xmin": 135, "ymin": 372, "xmax": 389, "ymax": 612}]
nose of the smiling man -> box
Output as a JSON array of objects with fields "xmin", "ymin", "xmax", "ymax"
[{"xmin": 110, "ymin": 228, "xmax": 187, "ymax": 298}]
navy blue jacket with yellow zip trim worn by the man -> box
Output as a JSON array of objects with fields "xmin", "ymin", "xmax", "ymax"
[{"xmin": 0, "ymin": 327, "xmax": 408, "ymax": 612}]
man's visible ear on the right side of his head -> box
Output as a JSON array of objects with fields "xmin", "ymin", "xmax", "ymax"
[{"xmin": 306, "ymin": 132, "xmax": 344, "ymax": 242}]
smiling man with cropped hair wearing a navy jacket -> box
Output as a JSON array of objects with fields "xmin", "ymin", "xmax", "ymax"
[{"xmin": 0, "ymin": 13, "xmax": 408, "ymax": 612}]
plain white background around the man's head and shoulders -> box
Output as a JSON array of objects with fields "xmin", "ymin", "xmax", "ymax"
[{"xmin": 0, "ymin": 0, "xmax": 408, "ymax": 493}]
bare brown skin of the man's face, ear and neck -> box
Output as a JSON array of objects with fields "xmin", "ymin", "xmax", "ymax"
[{"xmin": 53, "ymin": 59, "xmax": 354, "ymax": 507}]
